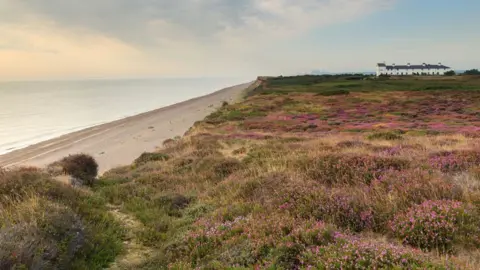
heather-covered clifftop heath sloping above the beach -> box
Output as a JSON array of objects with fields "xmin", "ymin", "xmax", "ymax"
[{"xmin": 0, "ymin": 75, "xmax": 480, "ymax": 269}]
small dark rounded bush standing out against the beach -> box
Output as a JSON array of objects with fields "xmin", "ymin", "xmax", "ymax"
[{"xmin": 60, "ymin": 154, "xmax": 98, "ymax": 186}]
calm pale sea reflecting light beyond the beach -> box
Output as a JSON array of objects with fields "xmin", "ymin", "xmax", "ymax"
[{"xmin": 0, "ymin": 78, "xmax": 248, "ymax": 154}]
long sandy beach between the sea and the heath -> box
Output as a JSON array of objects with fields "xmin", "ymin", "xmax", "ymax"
[{"xmin": 0, "ymin": 83, "xmax": 252, "ymax": 173}]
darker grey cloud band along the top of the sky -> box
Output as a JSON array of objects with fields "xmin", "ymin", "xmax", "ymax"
[{"xmin": 0, "ymin": 0, "xmax": 394, "ymax": 44}]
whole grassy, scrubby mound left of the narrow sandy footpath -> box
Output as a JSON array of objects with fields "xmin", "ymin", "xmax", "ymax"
[{"xmin": 0, "ymin": 169, "xmax": 124, "ymax": 269}]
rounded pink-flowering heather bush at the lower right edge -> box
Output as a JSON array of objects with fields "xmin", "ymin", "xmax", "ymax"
[{"xmin": 390, "ymin": 200, "xmax": 480, "ymax": 252}]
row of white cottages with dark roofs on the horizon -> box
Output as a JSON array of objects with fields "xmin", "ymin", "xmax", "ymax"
[{"xmin": 377, "ymin": 63, "xmax": 452, "ymax": 76}]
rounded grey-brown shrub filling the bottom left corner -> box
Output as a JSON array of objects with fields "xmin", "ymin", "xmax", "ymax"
[{"xmin": 0, "ymin": 198, "xmax": 86, "ymax": 269}]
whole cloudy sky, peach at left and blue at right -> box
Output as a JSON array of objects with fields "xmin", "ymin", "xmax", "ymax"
[{"xmin": 0, "ymin": 0, "xmax": 480, "ymax": 80}]
